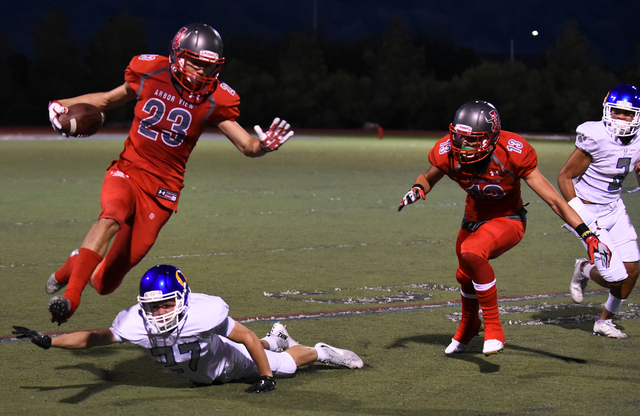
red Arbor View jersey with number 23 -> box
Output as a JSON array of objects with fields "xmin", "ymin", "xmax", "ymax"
[{"xmin": 112, "ymin": 55, "xmax": 240, "ymax": 211}]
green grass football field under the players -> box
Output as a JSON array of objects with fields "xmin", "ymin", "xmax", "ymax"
[{"xmin": 0, "ymin": 138, "xmax": 640, "ymax": 416}]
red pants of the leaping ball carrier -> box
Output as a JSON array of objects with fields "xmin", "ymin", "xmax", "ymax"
[{"xmin": 93, "ymin": 168, "xmax": 173, "ymax": 295}]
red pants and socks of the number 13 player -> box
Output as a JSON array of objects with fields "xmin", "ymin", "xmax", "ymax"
[{"xmin": 454, "ymin": 217, "xmax": 526, "ymax": 343}]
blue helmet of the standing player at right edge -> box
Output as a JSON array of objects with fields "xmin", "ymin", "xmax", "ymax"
[{"xmin": 602, "ymin": 84, "xmax": 640, "ymax": 137}]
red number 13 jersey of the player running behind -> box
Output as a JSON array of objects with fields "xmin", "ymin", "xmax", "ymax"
[{"xmin": 429, "ymin": 130, "xmax": 538, "ymax": 222}]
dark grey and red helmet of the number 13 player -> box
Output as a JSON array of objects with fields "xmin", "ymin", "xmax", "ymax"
[{"xmin": 449, "ymin": 101, "xmax": 500, "ymax": 164}]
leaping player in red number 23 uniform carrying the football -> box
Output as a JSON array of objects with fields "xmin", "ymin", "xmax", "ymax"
[{"xmin": 45, "ymin": 23, "xmax": 293, "ymax": 325}]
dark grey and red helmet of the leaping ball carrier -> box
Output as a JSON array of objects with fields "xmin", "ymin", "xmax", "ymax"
[{"xmin": 169, "ymin": 23, "xmax": 224, "ymax": 102}]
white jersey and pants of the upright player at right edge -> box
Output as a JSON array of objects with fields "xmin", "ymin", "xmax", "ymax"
[{"xmin": 573, "ymin": 121, "xmax": 640, "ymax": 282}]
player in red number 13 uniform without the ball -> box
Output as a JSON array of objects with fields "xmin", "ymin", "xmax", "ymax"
[{"xmin": 398, "ymin": 101, "xmax": 611, "ymax": 355}]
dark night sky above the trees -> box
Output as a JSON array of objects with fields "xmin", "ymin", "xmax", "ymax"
[{"xmin": 5, "ymin": 0, "xmax": 640, "ymax": 67}]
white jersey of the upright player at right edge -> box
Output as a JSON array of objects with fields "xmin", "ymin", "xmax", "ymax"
[{"xmin": 573, "ymin": 121, "xmax": 640, "ymax": 204}]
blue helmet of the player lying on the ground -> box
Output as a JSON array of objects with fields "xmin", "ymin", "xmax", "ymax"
[{"xmin": 138, "ymin": 264, "xmax": 191, "ymax": 334}]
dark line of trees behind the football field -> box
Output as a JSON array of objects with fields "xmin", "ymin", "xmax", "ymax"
[{"xmin": 0, "ymin": 7, "xmax": 640, "ymax": 133}]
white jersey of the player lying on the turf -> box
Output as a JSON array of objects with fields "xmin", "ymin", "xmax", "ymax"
[{"xmin": 111, "ymin": 293, "xmax": 258, "ymax": 384}]
